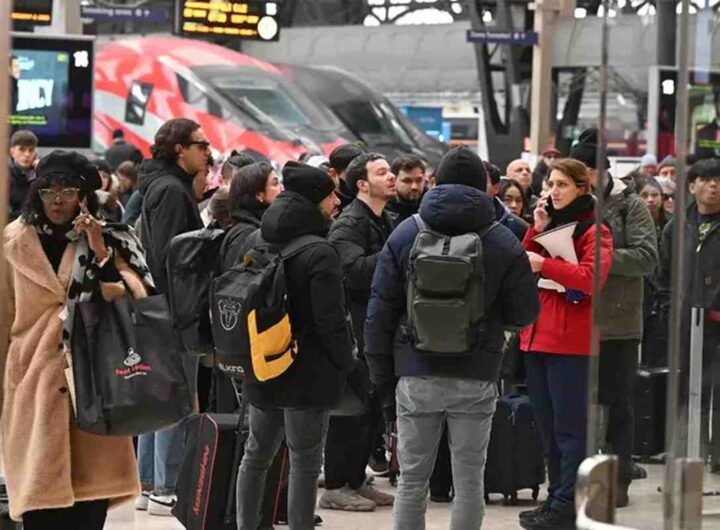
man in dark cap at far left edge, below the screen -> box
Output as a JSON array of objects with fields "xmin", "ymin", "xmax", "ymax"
[{"xmin": 8, "ymin": 130, "xmax": 38, "ymax": 221}]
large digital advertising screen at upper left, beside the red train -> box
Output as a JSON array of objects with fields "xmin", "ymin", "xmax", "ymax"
[{"xmin": 8, "ymin": 35, "xmax": 93, "ymax": 148}]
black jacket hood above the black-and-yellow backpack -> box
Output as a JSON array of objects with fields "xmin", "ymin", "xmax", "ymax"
[{"xmin": 260, "ymin": 190, "xmax": 329, "ymax": 243}]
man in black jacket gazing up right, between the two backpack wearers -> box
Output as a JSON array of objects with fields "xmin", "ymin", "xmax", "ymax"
[{"xmin": 320, "ymin": 153, "xmax": 395, "ymax": 511}]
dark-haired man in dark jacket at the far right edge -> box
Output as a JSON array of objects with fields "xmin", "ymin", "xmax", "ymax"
[{"xmin": 659, "ymin": 158, "xmax": 720, "ymax": 469}]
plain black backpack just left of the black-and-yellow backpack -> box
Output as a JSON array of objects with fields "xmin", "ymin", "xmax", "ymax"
[{"xmin": 167, "ymin": 226, "xmax": 225, "ymax": 355}]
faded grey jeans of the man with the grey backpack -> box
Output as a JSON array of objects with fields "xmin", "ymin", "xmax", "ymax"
[{"xmin": 393, "ymin": 377, "xmax": 497, "ymax": 530}]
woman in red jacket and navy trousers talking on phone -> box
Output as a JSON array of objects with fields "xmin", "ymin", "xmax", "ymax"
[{"xmin": 520, "ymin": 159, "xmax": 613, "ymax": 530}]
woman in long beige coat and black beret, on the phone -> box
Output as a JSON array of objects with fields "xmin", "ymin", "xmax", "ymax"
[{"xmin": 0, "ymin": 151, "xmax": 147, "ymax": 530}]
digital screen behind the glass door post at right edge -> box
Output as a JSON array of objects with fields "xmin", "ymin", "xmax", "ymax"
[{"xmin": 654, "ymin": 68, "xmax": 720, "ymax": 158}]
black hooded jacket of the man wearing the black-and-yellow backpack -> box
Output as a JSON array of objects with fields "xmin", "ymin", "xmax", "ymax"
[{"xmin": 244, "ymin": 190, "xmax": 353, "ymax": 408}]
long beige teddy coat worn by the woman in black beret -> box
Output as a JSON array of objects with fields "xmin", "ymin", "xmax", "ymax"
[{"xmin": 0, "ymin": 221, "xmax": 140, "ymax": 520}]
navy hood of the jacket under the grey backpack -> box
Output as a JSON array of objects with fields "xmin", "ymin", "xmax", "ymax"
[{"xmin": 420, "ymin": 184, "xmax": 495, "ymax": 235}]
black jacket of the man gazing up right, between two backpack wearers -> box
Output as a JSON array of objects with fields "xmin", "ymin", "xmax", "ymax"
[{"xmin": 328, "ymin": 199, "xmax": 393, "ymax": 352}]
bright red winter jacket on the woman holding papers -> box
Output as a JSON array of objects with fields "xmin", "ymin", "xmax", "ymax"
[{"xmin": 520, "ymin": 219, "xmax": 613, "ymax": 355}]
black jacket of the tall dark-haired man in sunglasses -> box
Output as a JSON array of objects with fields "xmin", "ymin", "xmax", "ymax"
[{"xmin": 138, "ymin": 160, "xmax": 203, "ymax": 293}]
